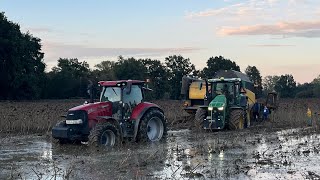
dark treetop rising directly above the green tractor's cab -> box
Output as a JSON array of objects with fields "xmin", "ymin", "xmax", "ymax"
[{"xmin": 203, "ymin": 56, "xmax": 240, "ymax": 78}]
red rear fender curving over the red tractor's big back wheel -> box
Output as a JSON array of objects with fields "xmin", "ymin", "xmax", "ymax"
[{"xmin": 130, "ymin": 102, "xmax": 164, "ymax": 141}]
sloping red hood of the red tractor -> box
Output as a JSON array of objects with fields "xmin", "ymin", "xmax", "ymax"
[{"xmin": 69, "ymin": 102, "xmax": 112, "ymax": 114}]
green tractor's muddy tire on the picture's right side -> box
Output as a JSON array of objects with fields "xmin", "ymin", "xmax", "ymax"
[{"xmin": 229, "ymin": 109, "xmax": 245, "ymax": 130}]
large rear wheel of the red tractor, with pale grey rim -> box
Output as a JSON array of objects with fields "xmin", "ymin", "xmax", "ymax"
[{"xmin": 137, "ymin": 109, "xmax": 167, "ymax": 142}]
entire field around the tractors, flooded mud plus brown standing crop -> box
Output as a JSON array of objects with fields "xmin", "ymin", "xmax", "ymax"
[{"xmin": 0, "ymin": 99, "xmax": 320, "ymax": 179}]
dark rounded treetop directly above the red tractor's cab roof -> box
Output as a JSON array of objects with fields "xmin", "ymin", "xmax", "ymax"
[{"xmin": 114, "ymin": 56, "xmax": 147, "ymax": 80}]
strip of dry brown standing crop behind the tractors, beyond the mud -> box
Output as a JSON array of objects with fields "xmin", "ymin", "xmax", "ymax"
[{"xmin": 0, "ymin": 99, "xmax": 320, "ymax": 134}]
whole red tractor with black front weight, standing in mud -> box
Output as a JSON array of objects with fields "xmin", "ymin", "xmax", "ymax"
[{"xmin": 52, "ymin": 80, "xmax": 167, "ymax": 147}]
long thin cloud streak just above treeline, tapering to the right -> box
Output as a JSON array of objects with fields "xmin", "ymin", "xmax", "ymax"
[{"xmin": 43, "ymin": 43, "xmax": 202, "ymax": 61}]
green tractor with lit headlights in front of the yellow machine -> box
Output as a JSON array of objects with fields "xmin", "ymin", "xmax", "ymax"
[{"xmin": 195, "ymin": 77, "xmax": 255, "ymax": 130}]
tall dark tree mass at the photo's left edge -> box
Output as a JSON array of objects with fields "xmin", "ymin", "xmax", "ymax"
[{"xmin": 0, "ymin": 12, "xmax": 45, "ymax": 99}]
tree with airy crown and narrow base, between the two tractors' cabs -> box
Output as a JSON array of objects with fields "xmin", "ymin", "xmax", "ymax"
[{"xmin": 165, "ymin": 55, "xmax": 195, "ymax": 99}]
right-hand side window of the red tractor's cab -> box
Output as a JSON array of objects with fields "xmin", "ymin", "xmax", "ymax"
[{"xmin": 123, "ymin": 85, "xmax": 142, "ymax": 107}]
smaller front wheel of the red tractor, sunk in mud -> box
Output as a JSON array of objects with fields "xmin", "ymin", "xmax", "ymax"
[{"xmin": 88, "ymin": 122, "xmax": 121, "ymax": 147}]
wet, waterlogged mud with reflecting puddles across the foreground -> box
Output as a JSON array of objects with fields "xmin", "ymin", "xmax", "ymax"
[{"xmin": 0, "ymin": 128, "xmax": 320, "ymax": 179}]
